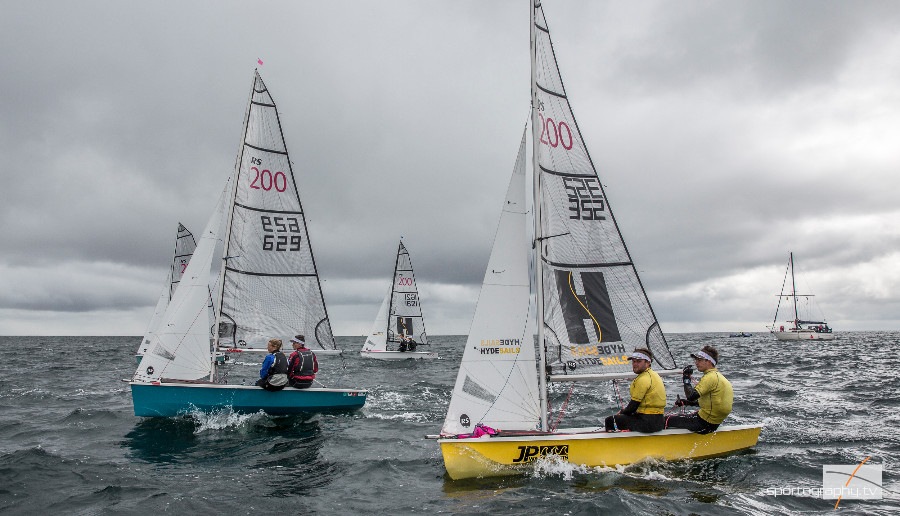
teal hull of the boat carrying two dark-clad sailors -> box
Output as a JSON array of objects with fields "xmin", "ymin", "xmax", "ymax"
[{"xmin": 131, "ymin": 382, "xmax": 368, "ymax": 417}]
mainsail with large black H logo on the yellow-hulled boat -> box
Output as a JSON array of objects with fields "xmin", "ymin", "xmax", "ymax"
[{"xmin": 531, "ymin": 4, "xmax": 675, "ymax": 375}]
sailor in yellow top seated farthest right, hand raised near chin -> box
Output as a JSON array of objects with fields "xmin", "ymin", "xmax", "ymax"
[{"xmin": 666, "ymin": 346, "xmax": 734, "ymax": 434}]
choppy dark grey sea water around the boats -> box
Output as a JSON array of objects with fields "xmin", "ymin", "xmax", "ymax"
[{"xmin": 0, "ymin": 332, "xmax": 900, "ymax": 515}]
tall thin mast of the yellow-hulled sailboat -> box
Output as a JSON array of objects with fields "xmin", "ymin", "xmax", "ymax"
[{"xmin": 526, "ymin": 0, "xmax": 550, "ymax": 431}]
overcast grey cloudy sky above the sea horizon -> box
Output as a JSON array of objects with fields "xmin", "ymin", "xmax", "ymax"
[{"xmin": 0, "ymin": 0, "xmax": 900, "ymax": 335}]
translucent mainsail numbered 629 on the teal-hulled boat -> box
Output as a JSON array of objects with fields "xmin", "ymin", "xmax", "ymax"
[{"xmin": 219, "ymin": 73, "xmax": 335, "ymax": 350}]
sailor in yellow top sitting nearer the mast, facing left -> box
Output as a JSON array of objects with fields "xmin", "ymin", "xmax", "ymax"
[{"xmin": 605, "ymin": 348, "xmax": 666, "ymax": 433}]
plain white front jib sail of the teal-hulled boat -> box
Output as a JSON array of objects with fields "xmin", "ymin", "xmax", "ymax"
[{"xmin": 132, "ymin": 180, "xmax": 231, "ymax": 382}]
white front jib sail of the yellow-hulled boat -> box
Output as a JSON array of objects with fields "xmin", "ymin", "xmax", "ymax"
[{"xmin": 441, "ymin": 135, "xmax": 541, "ymax": 435}]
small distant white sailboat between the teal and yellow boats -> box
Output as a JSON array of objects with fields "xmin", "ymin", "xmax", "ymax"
[{"xmin": 359, "ymin": 240, "xmax": 440, "ymax": 360}]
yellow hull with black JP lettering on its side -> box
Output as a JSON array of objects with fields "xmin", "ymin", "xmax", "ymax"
[{"xmin": 438, "ymin": 425, "xmax": 762, "ymax": 480}]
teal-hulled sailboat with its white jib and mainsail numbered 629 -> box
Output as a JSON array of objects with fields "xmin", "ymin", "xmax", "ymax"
[{"xmin": 130, "ymin": 72, "xmax": 367, "ymax": 416}]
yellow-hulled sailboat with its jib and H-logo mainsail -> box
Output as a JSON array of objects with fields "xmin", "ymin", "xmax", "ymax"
[{"xmin": 433, "ymin": 0, "xmax": 761, "ymax": 479}]
